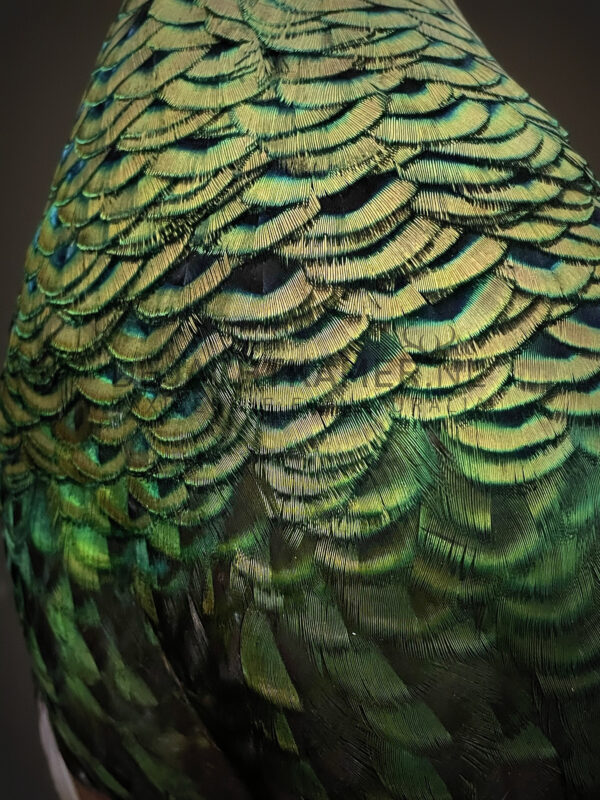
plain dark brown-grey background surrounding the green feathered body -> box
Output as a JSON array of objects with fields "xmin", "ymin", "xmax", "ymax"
[{"xmin": 0, "ymin": 0, "xmax": 600, "ymax": 800}]
